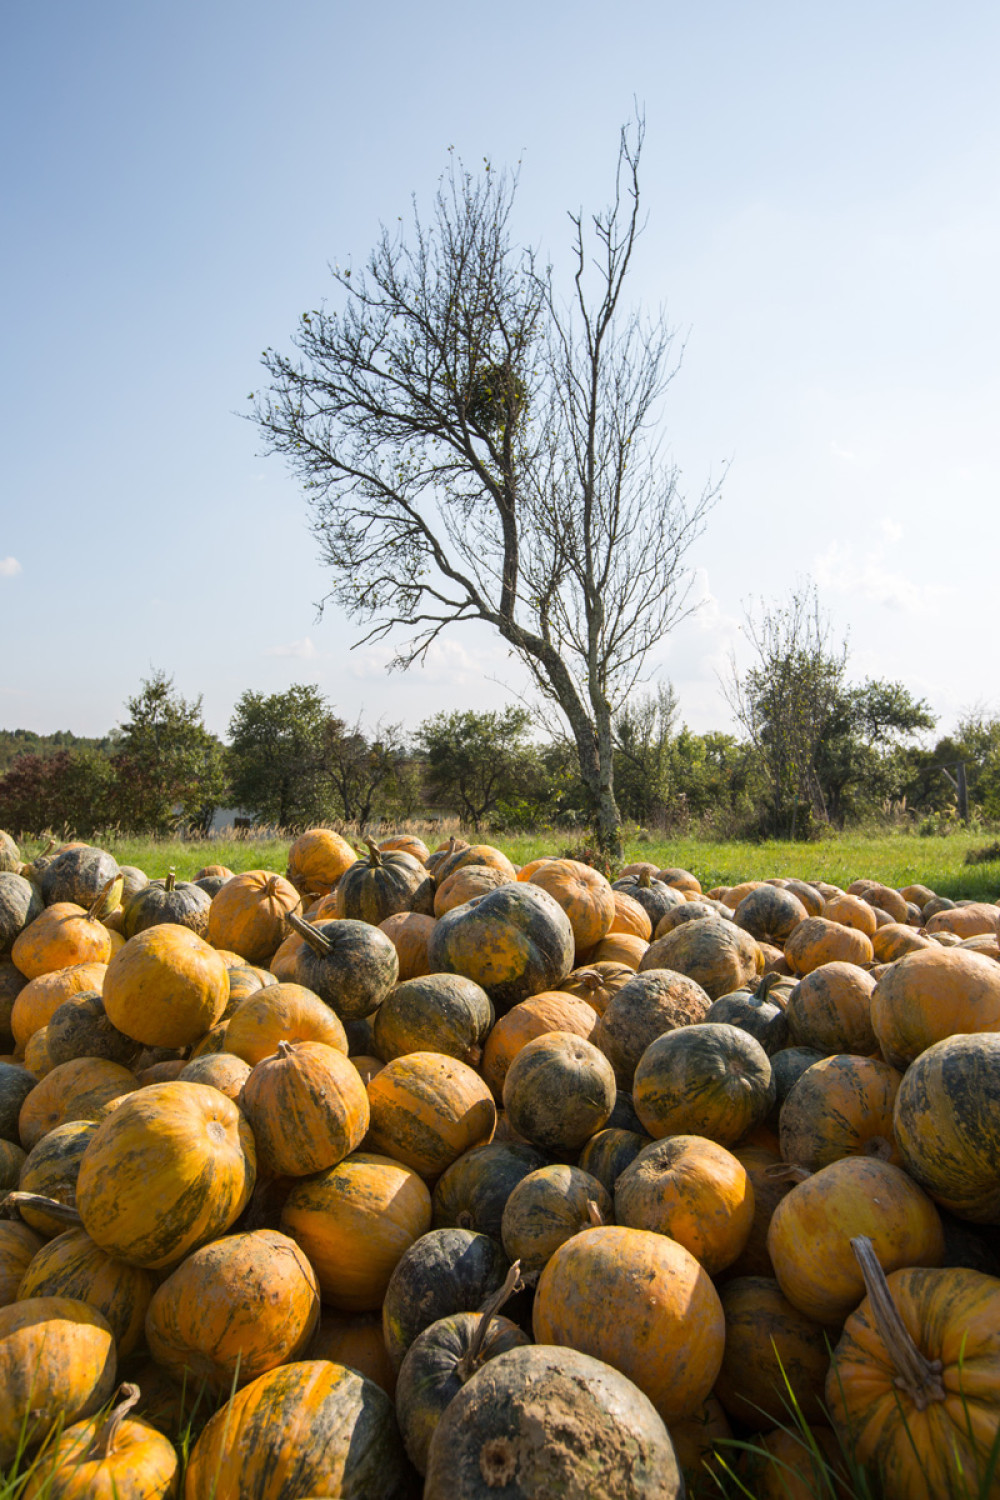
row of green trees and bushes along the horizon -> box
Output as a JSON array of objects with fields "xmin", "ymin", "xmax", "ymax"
[{"xmin": 0, "ymin": 672, "xmax": 1000, "ymax": 839}]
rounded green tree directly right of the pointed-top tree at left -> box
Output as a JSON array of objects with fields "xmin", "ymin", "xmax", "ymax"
[{"xmin": 228, "ymin": 683, "xmax": 334, "ymax": 828}]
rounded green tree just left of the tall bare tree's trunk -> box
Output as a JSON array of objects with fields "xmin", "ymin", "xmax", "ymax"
[{"xmin": 417, "ymin": 707, "xmax": 531, "ymax": 828}]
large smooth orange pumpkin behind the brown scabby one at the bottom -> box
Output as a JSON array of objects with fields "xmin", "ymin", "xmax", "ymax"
[{"xmin": 532, "ymin": 1226, "xmax": 726, "ymax": 1422}]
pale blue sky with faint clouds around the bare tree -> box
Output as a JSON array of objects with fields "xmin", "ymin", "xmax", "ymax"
[{"xmin": 0, "ymin": 0, "xmax": 1000, "ymax": 734}]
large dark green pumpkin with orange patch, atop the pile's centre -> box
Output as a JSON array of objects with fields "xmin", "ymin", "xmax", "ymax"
[{"xmin": 429, "ymin": 881, "xmax": 574, "ymax": 1013}]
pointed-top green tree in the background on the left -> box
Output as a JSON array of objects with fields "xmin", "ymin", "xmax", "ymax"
[{"xmin": 112, "ymin": 671, "xmax": 225, "ymax": 833}]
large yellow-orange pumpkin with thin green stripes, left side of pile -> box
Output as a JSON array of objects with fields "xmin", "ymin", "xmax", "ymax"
[{"xmin": 76, "ymin": 1086, "xmax": 256, "ymax": 1271}]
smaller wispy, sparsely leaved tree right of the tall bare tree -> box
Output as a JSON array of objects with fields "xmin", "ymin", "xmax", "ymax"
[{"xmin": 723, "ymin": 582, "xmax": 847, "ymax": 839}]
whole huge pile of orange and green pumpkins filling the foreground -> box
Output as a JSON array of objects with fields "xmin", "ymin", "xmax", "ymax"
[{"xmin": 0, "ymin": 830, "xmax": 1000, "ymax": 1500}]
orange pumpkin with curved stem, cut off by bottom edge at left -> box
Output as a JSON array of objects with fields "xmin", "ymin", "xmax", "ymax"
[{"xmin": 24, "ymin": 1415, "xmax": 180, "ymax": 1500}]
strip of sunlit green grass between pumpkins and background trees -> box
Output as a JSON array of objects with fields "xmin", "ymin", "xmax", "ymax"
[{"xmin": 22, "ymin": 822, "xmax": 1000, "ymax": 900}]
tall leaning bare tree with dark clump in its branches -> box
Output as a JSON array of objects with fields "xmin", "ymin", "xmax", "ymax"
[{"xmin": 253, "ymin": 120, "xmax": 718, "ymax": 854}]
